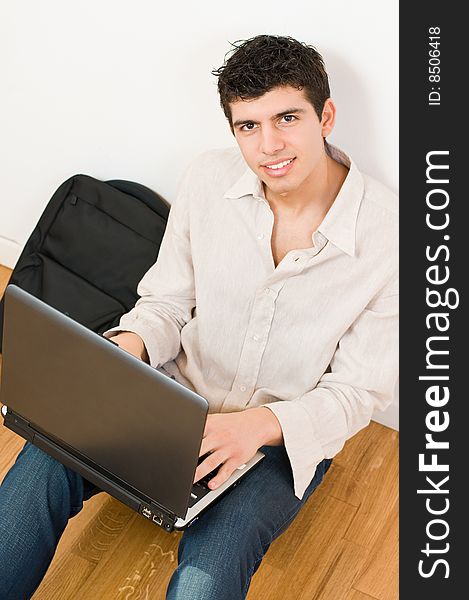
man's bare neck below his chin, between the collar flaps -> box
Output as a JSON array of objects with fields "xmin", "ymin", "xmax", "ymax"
[{"xmin": 263, "ymin": 153, "xmax": 348, "ymax": 218}]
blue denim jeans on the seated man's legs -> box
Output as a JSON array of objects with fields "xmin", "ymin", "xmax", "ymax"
[{"xmin": 0, "ymin": 442, "xmax": 332, "ymax": 600}]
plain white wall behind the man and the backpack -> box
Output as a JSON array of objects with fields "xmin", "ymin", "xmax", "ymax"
[{"xmin": 0, "ymin": 0, "xmax": 398, "ymax": 428}]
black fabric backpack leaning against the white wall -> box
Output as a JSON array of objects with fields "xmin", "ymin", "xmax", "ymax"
[{"xmin": 0, "ymin": 175, "xmax": 169, "ymax": 351}]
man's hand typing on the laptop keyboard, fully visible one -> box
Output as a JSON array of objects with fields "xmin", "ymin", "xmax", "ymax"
[{"xmin": 194, "ymin": 406, "xmax": 283, "ymax": 489}]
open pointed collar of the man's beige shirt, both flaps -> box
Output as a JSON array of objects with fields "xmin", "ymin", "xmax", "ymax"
[{"xmin": 224, "ymin": 142, "xmax": 365, "ymax": 256}]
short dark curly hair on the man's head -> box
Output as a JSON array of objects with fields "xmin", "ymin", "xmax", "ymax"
[{"xmin": 212, "ymin": 35, "xmax": 330, "ymax": 131}]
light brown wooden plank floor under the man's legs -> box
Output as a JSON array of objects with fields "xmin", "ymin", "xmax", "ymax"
[{"xmin": 0, "ymin": 266, "xmax": 399, "ymax": 600}]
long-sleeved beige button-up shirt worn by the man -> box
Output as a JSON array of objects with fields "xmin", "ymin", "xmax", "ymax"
[{"xmin": 101, "ymin": 146, "xmax": 398, "ymax": 498}]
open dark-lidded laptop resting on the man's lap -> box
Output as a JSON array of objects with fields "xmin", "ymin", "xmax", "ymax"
[{"xmin": 0, "ymin": 284, "xmax": 264, "ymax": 532}]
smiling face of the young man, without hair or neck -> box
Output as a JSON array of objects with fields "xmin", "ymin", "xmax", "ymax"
[{"xmin": 230, "ymin": 86, "xmax": 334, "ymax": 195}]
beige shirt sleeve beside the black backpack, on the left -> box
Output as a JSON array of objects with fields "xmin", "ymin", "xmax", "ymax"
[{"xmin": 103, "ymin": 166, "xmax": 195, "ymax": 368}]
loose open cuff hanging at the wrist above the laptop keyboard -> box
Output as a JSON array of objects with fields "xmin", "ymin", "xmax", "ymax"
[{"xmin": 262, "ymin": 400, "xmax": 326, "ymax": 500}]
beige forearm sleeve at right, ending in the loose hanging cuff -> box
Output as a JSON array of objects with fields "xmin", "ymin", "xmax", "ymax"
[{"xmin": 263, "ymin": 278, "xmax": 399, "ymax": 499}]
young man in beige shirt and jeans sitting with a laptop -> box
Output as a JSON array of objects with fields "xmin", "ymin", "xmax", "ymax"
[{"xmin": 0, "ymin": 35, "xmax": 398, "ymax": 600}]
